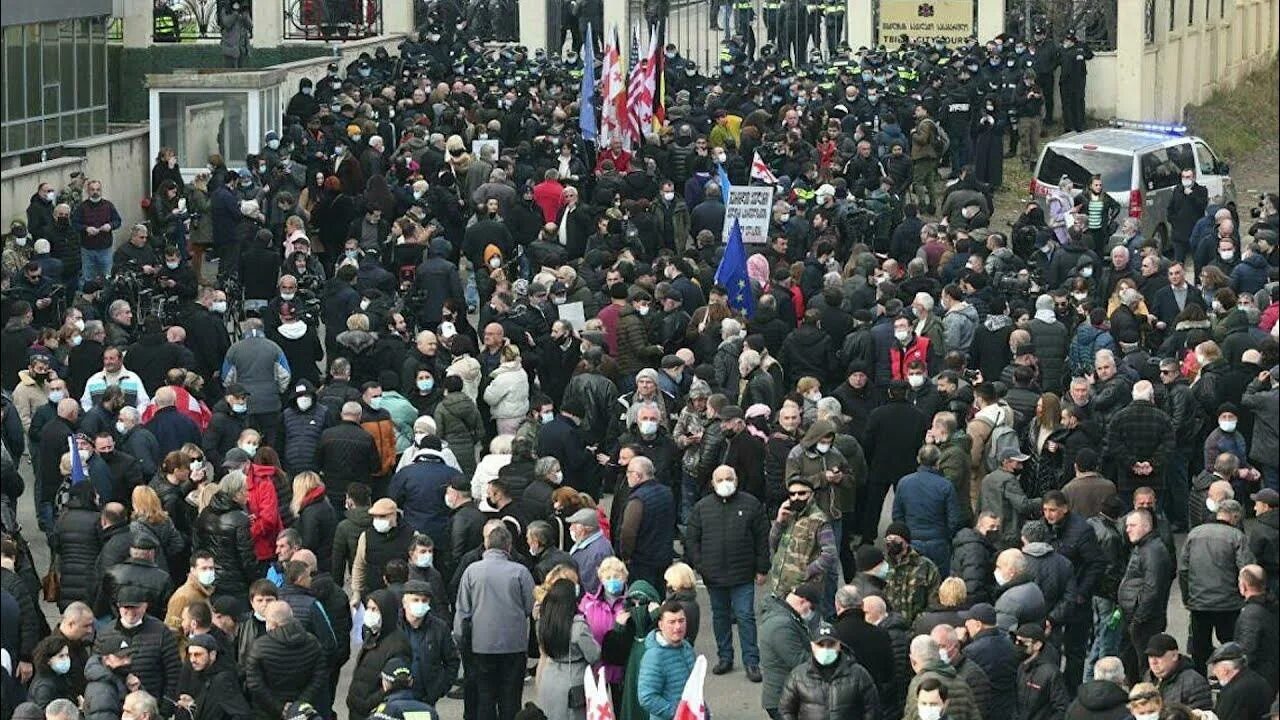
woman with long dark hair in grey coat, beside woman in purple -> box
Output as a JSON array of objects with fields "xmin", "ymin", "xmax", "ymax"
[{"xmin": 536, "ymin": 578, "xmax": 601, "ymax": 720}]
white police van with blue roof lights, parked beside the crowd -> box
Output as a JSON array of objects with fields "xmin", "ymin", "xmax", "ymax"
[{"xmin": 1030, "ymin": 120, "xmax": 1235, "ymax": 249}]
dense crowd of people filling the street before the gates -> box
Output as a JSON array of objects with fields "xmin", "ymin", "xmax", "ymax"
[{"xmin": 0, "ymin": 15, "xmax": 1280, "ymax": 720}]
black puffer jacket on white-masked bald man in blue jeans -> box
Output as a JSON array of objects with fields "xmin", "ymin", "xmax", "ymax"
[{"xmin": 685, "ymin": 491, "xmax": 769, "ymax": 588}]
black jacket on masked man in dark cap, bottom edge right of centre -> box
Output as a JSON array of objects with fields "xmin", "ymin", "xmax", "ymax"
[{"xmin": 778, "ymin": 651, "xmax": 881, "ymax": 720}]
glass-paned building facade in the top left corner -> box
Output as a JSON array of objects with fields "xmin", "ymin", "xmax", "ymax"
[{"xmin": 0, "ymin": 17, "xmax": 109, "ymax": 158}]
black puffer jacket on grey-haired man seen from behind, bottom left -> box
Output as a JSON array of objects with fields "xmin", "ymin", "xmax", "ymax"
[{"xmin": 242, "ymin": 621, "xmax": 329, "ymax": 720}]
